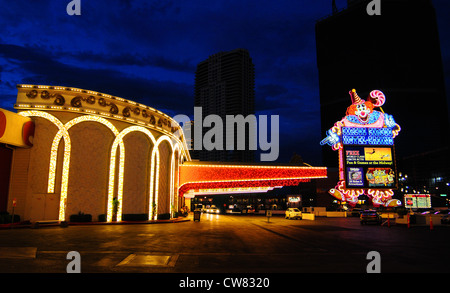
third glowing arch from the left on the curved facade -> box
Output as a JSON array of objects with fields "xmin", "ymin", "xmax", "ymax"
[{"xmin": 107, "ymin": 126, "xmax": 156, "ymax": 222}]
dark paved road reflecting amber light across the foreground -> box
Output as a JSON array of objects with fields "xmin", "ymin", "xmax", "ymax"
[{"xmin": 0, "ymin": 214, "xmax": 450, "ymax": 274}]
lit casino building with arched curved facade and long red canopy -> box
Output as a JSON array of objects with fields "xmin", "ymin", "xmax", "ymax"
[{"xmin": 0, "ymin": 85, "xmax": 327, "ymax": 222}]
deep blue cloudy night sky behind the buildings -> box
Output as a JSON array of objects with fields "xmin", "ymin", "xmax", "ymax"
[{"xmin": 0, "ymin": 0, "xmax": 450, "ymax": 165}]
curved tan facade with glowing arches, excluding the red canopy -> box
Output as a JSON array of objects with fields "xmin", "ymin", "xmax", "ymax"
[{"xmin": 9, "ymin": 85, "xmax": 190, "ymax": 221}]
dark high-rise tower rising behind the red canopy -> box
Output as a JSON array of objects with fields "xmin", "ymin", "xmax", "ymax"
[{"xmin": 192, "ymin": 49, "xmax": 255, "ymax": 162}]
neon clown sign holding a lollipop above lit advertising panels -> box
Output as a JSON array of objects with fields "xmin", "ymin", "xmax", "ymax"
[{"xmin": 320, "ymin": 89, "xmax": 401, "ymax": 207}]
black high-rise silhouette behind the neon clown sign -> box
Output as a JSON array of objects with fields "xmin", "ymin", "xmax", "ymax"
[{"xmin": 316, "ymin": 0, "xmax": 450, "ymax": 196}]
